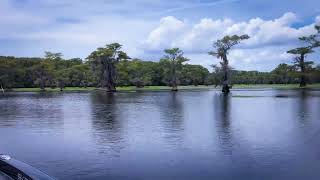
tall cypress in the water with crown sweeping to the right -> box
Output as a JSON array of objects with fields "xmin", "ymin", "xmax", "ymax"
[{"xmin": 209, "ymin": 35, "xmax": 250, "ymax": 93}]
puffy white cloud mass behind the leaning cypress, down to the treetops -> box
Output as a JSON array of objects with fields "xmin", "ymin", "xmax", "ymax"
[{"xmin": 143, "ymin": 12, "xmax": 319, "ymax": 70}]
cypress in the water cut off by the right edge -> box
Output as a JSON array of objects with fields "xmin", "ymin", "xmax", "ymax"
[{"xmin": 287, "ymin": 26, "xmax": 320, "ymax": 87}]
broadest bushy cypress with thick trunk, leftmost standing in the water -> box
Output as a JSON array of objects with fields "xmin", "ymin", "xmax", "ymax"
[{"xmin": 87, "ymin": 43, "xmax": 130, "ymax": 92}]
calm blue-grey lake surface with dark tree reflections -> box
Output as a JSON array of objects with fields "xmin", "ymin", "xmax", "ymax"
[{"xmin": 0, "ymin": 90, "xmax": 320, "ymax": 180}]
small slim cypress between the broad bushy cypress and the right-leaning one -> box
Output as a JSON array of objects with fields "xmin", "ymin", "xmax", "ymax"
[{"xmin": 162, "ymin": 48, "xmax": 188, "ymax": 91}]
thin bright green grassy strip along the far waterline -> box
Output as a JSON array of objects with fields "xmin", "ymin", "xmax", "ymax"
[{"xmin": 12, "ymin": 84, "xmax": 320, "ymax": 92}]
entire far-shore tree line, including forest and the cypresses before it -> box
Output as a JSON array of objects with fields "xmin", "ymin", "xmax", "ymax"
[{"xmin": 0, "ymin": 26, "xmax": 320, "ymax": 93}]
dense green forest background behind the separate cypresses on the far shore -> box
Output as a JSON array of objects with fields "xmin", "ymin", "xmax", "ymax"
[{"xmin": 0, "ymin": 52, "xmax": 320, "ymax": 89}]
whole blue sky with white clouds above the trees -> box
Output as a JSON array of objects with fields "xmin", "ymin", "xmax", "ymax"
[{"xmin": 0, "ymin": 0, "xmax": 320, "ymax": 71}]
